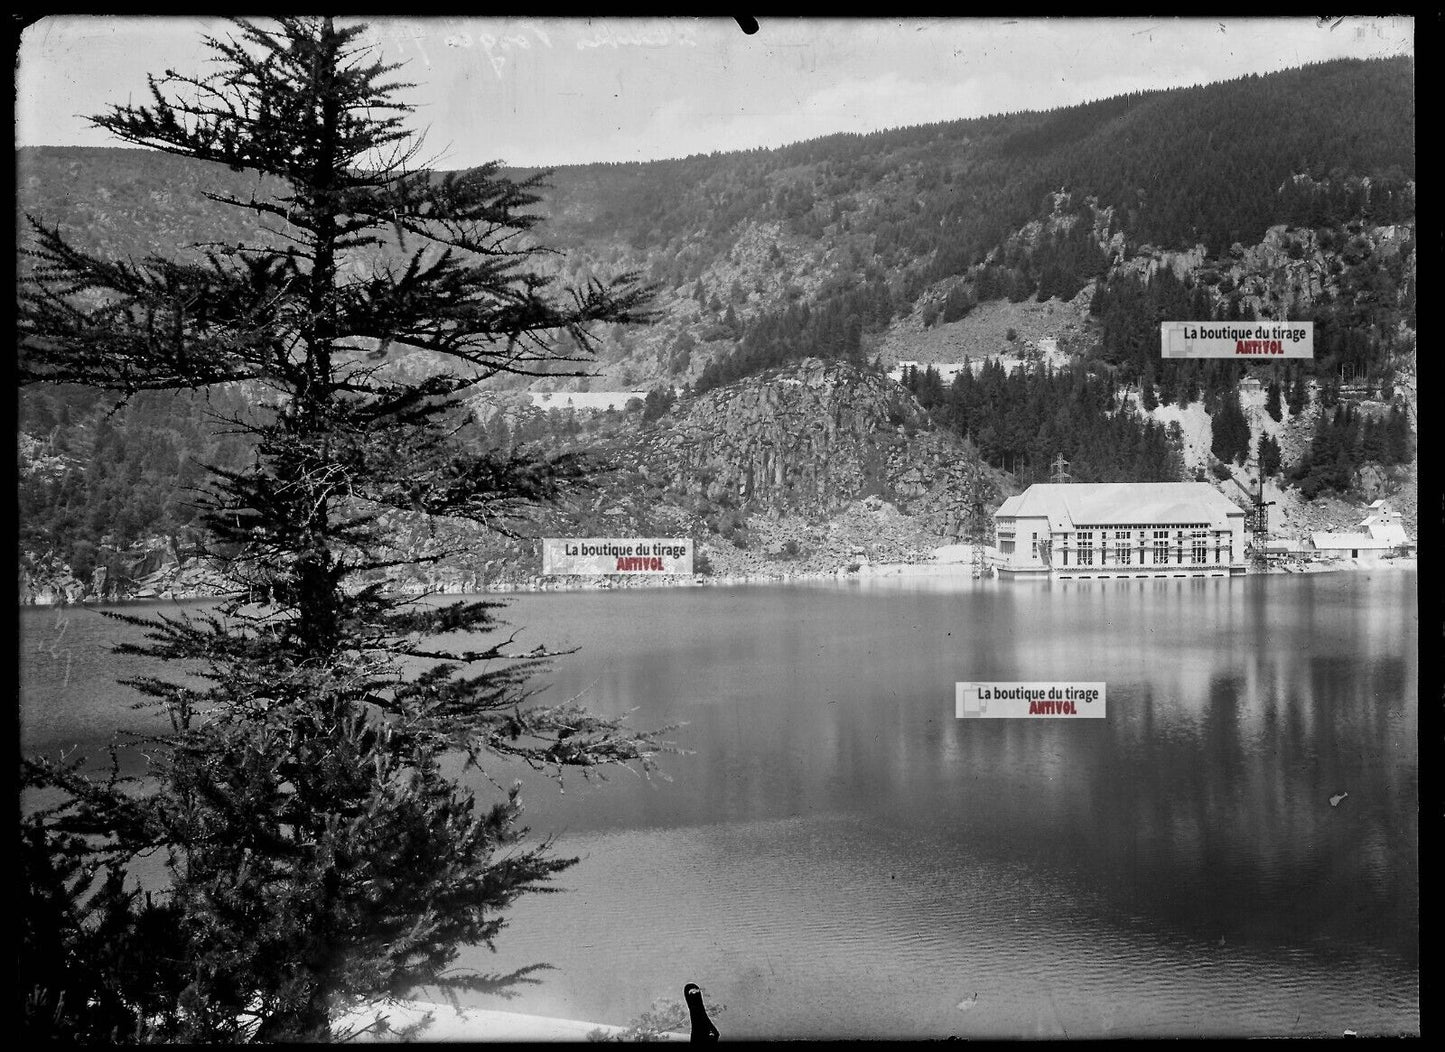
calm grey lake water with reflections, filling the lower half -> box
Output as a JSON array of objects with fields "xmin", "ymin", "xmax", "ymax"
[{"xmin": 22, "ymin": 571, "xmax": 1419, "ymax": 1039}]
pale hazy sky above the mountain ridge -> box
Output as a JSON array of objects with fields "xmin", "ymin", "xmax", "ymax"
[{"xmin": 16, "ymin": 16, "xmax": 1415, "ymax": 168}]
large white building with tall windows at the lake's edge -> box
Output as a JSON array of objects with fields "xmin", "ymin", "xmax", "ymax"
[{"xmin": 994, "ymin": 483, "xmax": 1244, "ymax": 579}]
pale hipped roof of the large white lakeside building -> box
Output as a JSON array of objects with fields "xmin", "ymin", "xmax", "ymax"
[{"xmin": 994, "ymin": 483, "xmax": 1244, "ymax": 530}]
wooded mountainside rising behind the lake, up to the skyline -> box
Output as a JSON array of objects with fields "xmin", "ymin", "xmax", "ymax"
[{"xmin": 17, "ymin": 58, "xmax": 1418, "ymax": 601}]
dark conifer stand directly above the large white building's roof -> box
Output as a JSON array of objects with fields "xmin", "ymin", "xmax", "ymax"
[{"xmin": 903, "ymin": 360, "xmax": 1183, "ymax": 484}]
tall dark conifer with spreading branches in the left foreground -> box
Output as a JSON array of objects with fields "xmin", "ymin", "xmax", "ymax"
[{"xmin": 19, "ymin": 17, "xmax": 668, "ymax": 1042}]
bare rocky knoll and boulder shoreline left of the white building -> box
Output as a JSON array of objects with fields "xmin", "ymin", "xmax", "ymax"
[{"xmin": 20, "ymin": 358, "xmax": 1003, "ymax": 603}]
